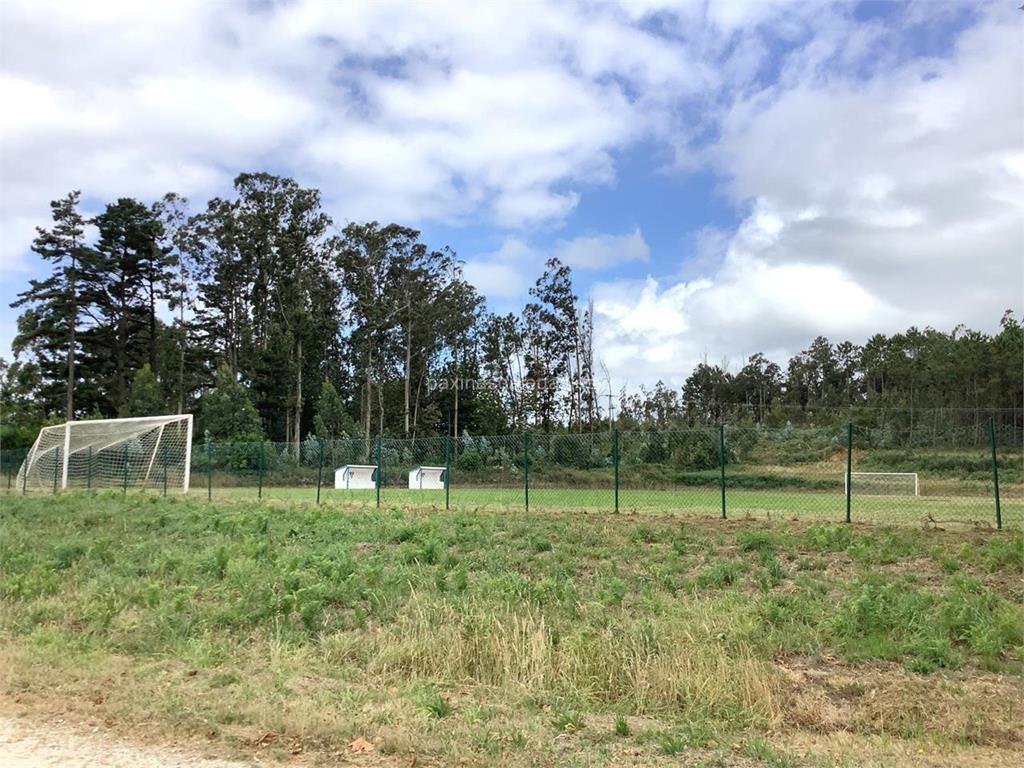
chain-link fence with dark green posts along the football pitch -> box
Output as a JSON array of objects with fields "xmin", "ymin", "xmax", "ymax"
[{"xmin": 0, "ymin": 422, "xmax": 1024, "ymax": 527}]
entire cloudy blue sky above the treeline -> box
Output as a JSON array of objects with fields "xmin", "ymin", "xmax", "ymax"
[{"xmin": 0, "ymin": 0, "xmax": 1024, "ymax": 388}]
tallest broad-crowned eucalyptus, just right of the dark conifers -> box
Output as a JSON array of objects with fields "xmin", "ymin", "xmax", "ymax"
[{"xmin": 185, "ymin": 173, "xmax": 341, "ymax": 451}]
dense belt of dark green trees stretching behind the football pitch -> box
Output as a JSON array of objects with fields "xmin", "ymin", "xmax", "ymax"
[{"xmin": 0, "ymin": 173, "xmax": 1024, "ymax": 447}]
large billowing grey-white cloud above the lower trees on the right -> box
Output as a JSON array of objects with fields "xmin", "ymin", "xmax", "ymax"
[{"xmin": 594, "ymin": 6, "xmax": 1024, "ymax": 391}]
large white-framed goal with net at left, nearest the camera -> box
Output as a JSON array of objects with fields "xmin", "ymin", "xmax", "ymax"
[{"xmin": 17, "ymin": 414, "xmax": 193, "ymax": 492}]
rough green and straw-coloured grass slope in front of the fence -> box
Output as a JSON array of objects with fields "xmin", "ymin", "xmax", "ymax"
[{"xmin": 0, "ymin": 490, "xmax": 1024, "ymax": 767}]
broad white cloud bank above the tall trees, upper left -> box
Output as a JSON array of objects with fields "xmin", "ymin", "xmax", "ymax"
[{"xmin": 0, "ymin": 0, "xmax": 709, "ymax": 276}]
